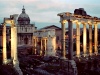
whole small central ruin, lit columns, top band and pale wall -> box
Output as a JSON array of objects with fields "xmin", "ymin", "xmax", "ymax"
[{"xmin": 33, "ymin": 29, "xmax": 56, "ymax": 56}]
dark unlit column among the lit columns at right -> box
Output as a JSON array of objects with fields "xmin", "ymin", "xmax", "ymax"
[{"xmin": 68, "ymin": 20, "xmax": 73, "ymax": 60}]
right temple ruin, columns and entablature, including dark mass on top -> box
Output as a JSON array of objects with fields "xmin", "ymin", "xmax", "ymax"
[{"xmin": 57, "ymin": 9, "xmax": 100, "ymax": 57}]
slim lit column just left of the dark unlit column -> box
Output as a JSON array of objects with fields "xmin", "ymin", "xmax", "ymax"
[{"xmin": 61, "ymin": 20, "xmax": 66, "ymax": 59}]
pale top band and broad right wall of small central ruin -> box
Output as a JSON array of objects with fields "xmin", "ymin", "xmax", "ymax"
[{"xmin": 33, "ymin": 29, "xmax": 56, "ymax": 56}]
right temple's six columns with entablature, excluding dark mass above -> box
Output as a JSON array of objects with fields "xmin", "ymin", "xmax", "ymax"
[{"xmin": 58, "ymin": 12, "xmax": 100, "ymax": 59}]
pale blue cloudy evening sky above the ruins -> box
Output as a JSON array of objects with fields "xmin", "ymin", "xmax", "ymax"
[{"xmin": 0, "ymin": 0, "xmax": 100, "ymax": 28}]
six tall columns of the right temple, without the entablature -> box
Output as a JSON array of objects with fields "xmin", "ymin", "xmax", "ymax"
[{"xmin": 61, "ymin": 20, "xmax": 98, "ymax": 59}]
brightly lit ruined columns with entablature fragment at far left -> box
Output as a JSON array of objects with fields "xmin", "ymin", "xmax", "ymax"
[{"xmin": 3, "ymin": 15, "xmax": 23, "ymax": 75}]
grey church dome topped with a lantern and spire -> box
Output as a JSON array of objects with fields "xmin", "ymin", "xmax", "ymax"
[{"xmin": 18, "ymin": 6, "xmax": 30, "ymax": 25}]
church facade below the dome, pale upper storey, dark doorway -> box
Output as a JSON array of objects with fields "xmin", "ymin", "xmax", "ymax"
[{"xmin": 17, "ymin": 25, "xmax": 35, "ymax": 46}]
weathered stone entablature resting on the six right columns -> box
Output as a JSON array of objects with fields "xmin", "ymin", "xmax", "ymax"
[{"xmin": 58, "ymin": 12, "xmax": 100, "ymax": 24}]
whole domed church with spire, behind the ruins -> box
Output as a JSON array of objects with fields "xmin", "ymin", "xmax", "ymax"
[{"xmin": 17, "ymin": 6, "xmax": 36, "ymax": 46}]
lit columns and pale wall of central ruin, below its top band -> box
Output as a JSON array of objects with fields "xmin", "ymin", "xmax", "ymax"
[{"xmin": 33, "ymin": 36, "xmax": 56, "ymax": 56}]
